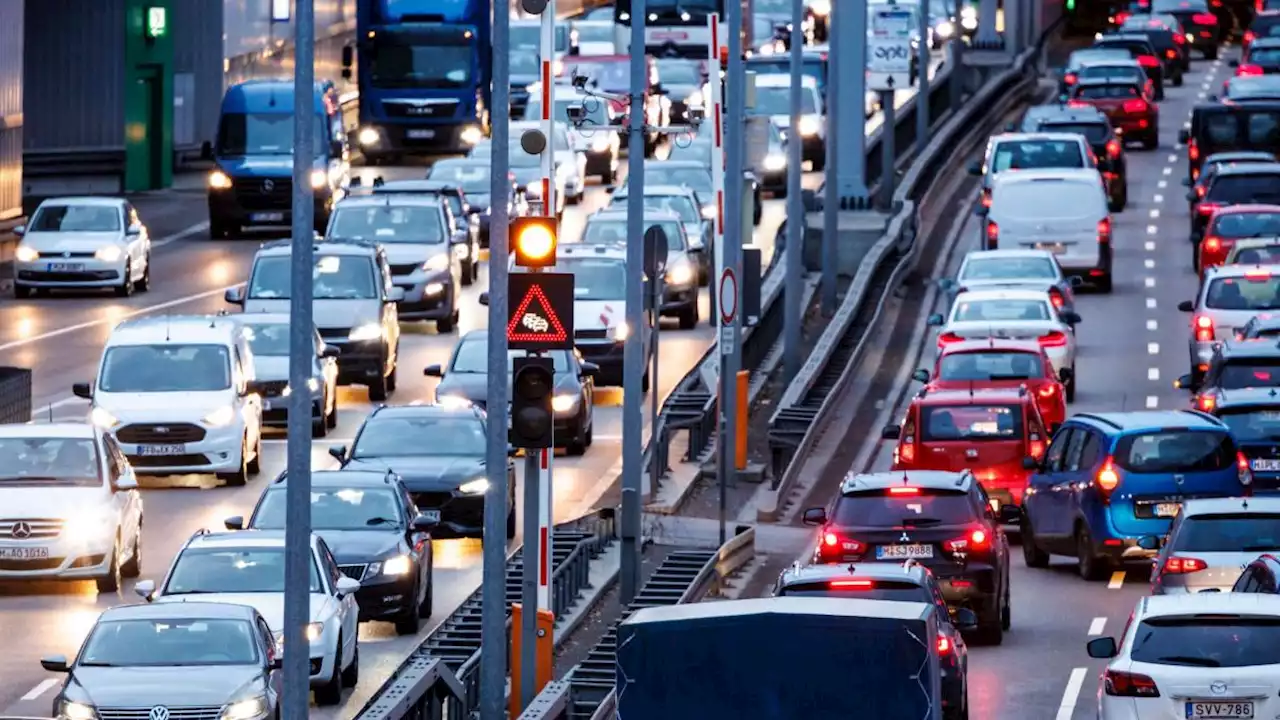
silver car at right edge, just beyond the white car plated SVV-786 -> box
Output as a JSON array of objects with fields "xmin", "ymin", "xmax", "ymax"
[{"xmin": 1139, "ymin": 496, "xmax": 1280, "ymax": 594}]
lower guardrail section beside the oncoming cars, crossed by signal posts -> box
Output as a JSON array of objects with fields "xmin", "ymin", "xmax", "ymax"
[{"xmin": 356, "ymin": 509, "xmax": 617, "ymax": 720}]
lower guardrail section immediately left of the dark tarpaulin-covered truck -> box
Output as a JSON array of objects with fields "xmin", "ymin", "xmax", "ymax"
[{"xmin": 520, "ymin": 525, "xmax": 755, "ymax": 720}]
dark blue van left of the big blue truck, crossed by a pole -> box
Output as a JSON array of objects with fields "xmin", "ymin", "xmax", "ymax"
[{"xmin": 201, "ymin": 79, "xmax": 351, "ymax": 238}]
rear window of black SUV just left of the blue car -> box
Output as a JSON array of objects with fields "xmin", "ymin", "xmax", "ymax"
[{"xmin": 832, "ymin": 487, "xmax": 977, "ymax": 528}]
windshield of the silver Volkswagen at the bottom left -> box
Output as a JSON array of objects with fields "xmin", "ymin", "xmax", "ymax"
[{"xmin": 77, "ymin": 617, "xmax": 259, "ymax": 667}]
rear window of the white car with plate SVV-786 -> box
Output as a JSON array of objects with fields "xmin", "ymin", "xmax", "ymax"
[{"xmin": 1129, "ymin": 615, "xmax": 1280, "ymax": 667}]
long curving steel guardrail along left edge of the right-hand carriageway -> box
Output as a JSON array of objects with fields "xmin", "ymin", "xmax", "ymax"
[{"xmin": 759, "ymin": 20, "xmax": 1061, "ymax": 512}]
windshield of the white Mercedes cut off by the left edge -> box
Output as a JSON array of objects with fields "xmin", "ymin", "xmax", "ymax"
[{"xmin": 0, "ymin": 437, "xmax": 102, "ymax": 487}]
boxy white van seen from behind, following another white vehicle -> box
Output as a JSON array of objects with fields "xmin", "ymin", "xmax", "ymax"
[{"xmin": 978, "ymin": 168, "xmax": 1111, "ymax": 292}]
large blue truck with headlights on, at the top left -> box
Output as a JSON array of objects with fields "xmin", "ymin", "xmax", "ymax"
[{"xmin": 342, "ymin": 0, "xmax": 491, "ymax": 163}]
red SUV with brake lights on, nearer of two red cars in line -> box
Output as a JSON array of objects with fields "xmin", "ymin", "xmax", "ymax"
[{"xmin": 881, "ymin": 384, "xmax": 1048, "ymax": 505}]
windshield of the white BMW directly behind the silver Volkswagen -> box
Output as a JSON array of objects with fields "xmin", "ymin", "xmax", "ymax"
[{"xmin": 161, "ymin": 545, "xmax": 321, "ymax": 594}]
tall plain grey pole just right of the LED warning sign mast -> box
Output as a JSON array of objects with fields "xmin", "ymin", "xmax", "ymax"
[{"xmin": 620, "ymin": 0, "xmax": 645, "ymax": 607}]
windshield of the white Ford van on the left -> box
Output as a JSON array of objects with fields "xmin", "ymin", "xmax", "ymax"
[{"xmin": 97, "ymin": 345, "xmax": 232, "ymax": 392}]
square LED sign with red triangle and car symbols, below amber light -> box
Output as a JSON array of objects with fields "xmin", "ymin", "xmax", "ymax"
[{"xmin": 507, "ymin": 273, "xmax": 573, "ymax": 351}]
